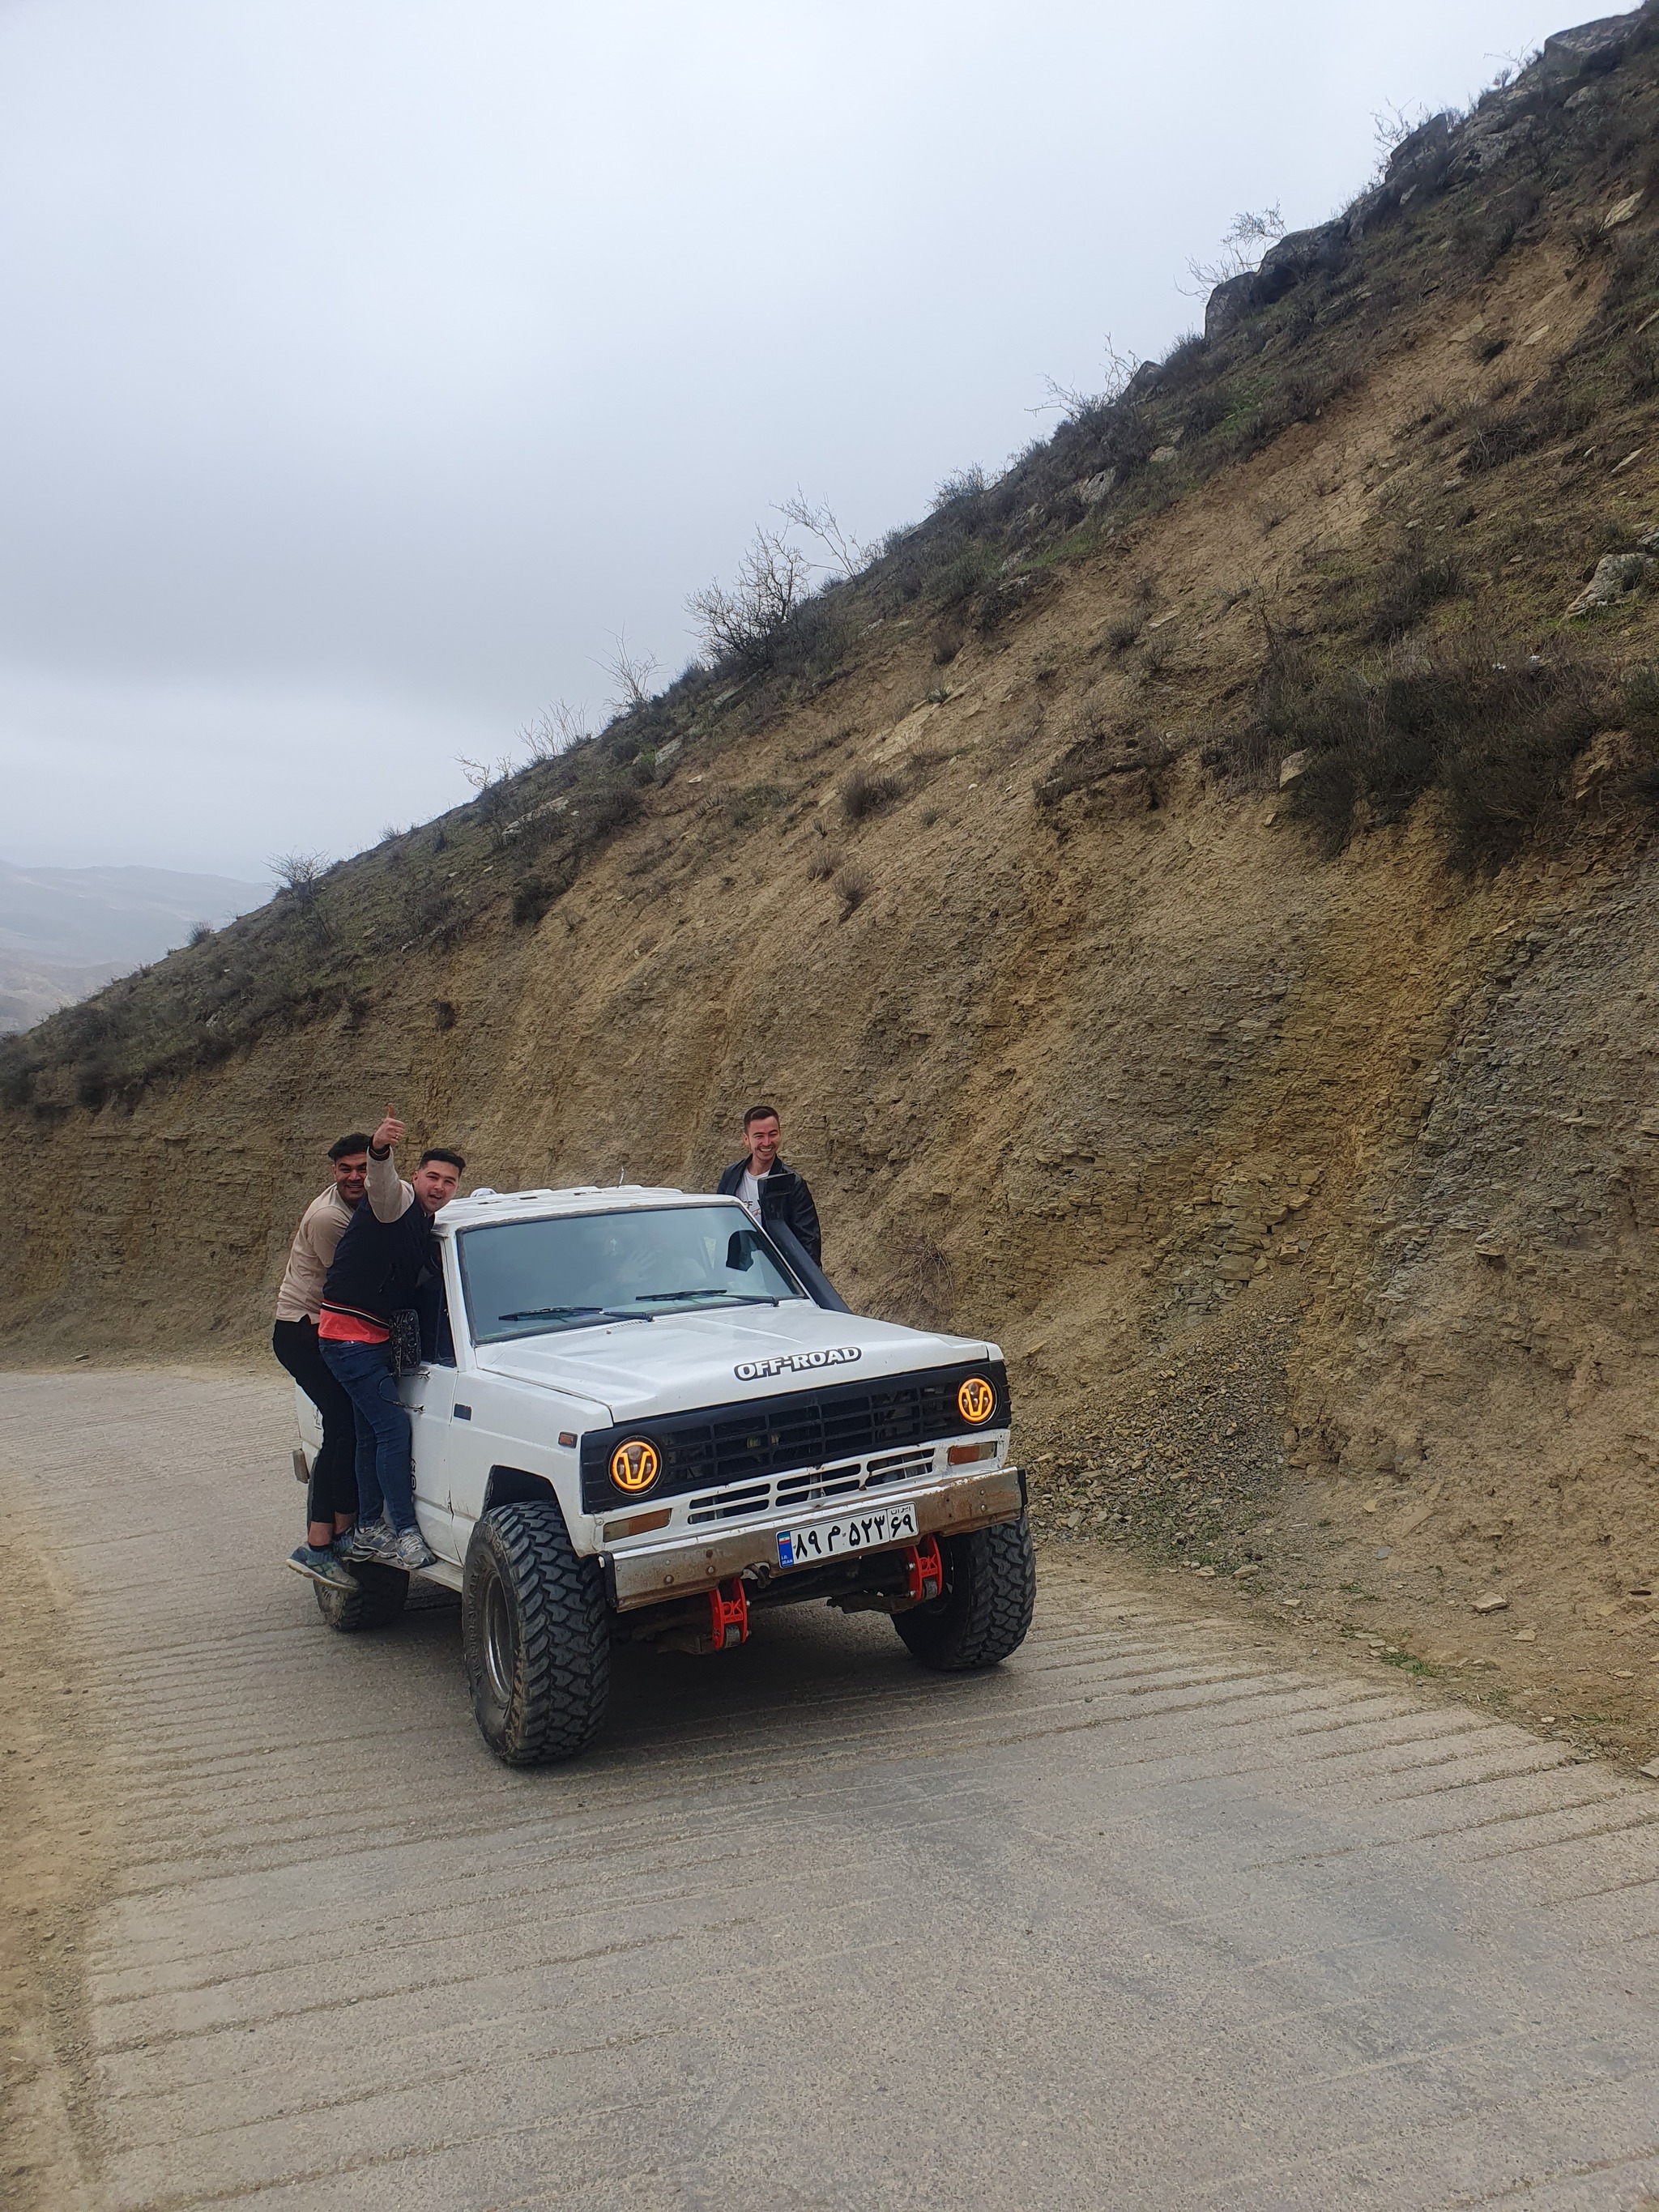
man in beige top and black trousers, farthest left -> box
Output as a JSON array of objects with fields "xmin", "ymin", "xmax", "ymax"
[{"xmin": 270, "ymin": 1131, "xmax": 369, "ymax": 1591}]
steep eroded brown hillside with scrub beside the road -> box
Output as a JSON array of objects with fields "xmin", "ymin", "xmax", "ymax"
[{"xmin": 2, "ymin": 9, "xmax": 1659, "ymax": 1756}]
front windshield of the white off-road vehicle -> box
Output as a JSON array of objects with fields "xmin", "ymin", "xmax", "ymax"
[{"xmin": 456, "ymin": 1205, "xmax": 805, "ymax": 1345}]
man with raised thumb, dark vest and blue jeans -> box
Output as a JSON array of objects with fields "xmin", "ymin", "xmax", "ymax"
[{"xmin": 316, "ymin": 1106, "xmax": 467, "ymax": 1571}]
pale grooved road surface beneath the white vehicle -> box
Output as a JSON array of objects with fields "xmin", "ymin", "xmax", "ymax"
[{"xmin": 0, "ymin": 1371, "xmax": 1659, "ymax": 2212}]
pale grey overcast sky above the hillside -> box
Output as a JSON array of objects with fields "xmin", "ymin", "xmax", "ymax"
[{"xmin": 0, "ymin": 0, "xmax": 1595, "ymax": 876}]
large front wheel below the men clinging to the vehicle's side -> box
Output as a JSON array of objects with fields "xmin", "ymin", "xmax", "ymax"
[{"xmin": 460, "ymin": 1502, "xmax": 611, "ymax": 1767}]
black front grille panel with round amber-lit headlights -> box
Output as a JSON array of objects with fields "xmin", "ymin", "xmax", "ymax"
[{"xmin": 582, "ymin": 1361, "xmax": 1009, "ymax": 1519}]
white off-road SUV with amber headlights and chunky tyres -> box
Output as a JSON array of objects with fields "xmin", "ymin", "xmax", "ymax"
[{"xmin": 296, "ymin": 1188, "xmax": 1035, "ymax": 1765}]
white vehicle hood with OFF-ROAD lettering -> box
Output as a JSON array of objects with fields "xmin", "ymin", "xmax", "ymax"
[{"xmin": 476, "ymin": 1303, "xmax": 1000, "ymax": 1422}]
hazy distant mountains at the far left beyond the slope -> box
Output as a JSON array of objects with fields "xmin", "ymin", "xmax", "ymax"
[{"xmin": 0, "ymin": 860, "xmax": 270, "ymax": 1031}]
